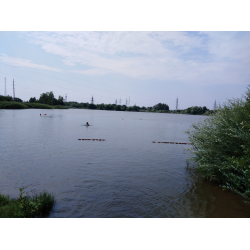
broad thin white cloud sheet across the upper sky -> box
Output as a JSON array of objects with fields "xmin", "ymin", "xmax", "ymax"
[{"xmin": 21, "ymin": 32, "xmax": 250, "ymax": 84}]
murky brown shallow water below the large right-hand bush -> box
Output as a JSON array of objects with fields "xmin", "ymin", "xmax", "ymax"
[{"xmin": 181, "ymin": 170, "xmax": 250, "ymax": 218}]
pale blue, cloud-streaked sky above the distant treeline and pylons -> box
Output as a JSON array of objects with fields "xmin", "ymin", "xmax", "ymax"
[{"xmin": 0, "ymin": 31, "xmax": 250, "ymax": 110}]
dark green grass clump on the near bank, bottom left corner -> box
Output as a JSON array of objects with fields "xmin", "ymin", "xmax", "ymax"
[{"xmin": 0, "ymin": 189, "xmax": 55, "ymax": 218}]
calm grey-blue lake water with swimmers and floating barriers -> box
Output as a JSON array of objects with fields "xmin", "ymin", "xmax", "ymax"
[{"xmin": 0, "ymin": 109, "xmax": 250, "ymax": 218}]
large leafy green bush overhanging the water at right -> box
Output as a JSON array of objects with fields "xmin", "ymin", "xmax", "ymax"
[{"xmin": 186, "ymin": 88, "xmax": 250, "ymax": 203}]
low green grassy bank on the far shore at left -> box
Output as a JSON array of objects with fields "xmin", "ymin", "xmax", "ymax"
[{"xmin": 0, "ymin": 101, "xmax": 68, "ymax": 109}]
